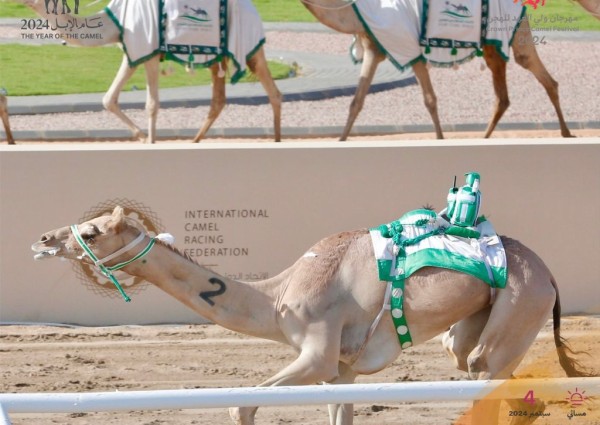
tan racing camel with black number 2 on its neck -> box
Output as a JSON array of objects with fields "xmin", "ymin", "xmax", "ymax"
[{"xmin": 32, "ymin": 206, "xmax": 587, "ymax": 425}]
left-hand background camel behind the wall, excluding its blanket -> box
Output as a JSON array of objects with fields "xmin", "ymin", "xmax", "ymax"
[{"xmin": 18, "ymin": 0, "xmax": 282, "ymax": 143}]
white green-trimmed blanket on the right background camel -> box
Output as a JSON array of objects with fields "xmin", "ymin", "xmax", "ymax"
[{"xmin": 353, "ymin": 0, "xmax": 525, "ymax": 70}]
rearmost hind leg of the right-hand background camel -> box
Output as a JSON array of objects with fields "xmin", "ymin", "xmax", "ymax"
[{"xmin": 512, "ymin": 17, "xmax": 574, "ymax": 137}]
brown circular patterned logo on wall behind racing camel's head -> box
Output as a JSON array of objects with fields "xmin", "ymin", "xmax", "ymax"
[{"xmin": 73, "ymin": 198, "xmax": 163, "ymax": 298}]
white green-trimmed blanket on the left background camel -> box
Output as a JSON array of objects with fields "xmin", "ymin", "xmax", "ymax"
[{"xmin": 105, "ymin": 0, "xmax": 265, "ymax": 83}]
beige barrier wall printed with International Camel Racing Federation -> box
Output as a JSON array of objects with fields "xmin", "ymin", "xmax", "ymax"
[{"xmin": 0, "ymin": 139, "xmax": 600, "ymax": 325}]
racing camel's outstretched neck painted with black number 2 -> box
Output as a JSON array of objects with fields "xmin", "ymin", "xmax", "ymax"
[{"xmin": 123, "ymin": 243, "xmax": 283, "ymax": 341}]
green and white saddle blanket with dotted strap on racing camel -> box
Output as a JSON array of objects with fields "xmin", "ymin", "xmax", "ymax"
[{"xmin": 370, "ymin": 209, "xmax": 507, "ymax": 348}]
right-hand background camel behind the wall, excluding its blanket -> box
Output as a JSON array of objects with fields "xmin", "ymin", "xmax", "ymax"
[{"xmin": 300, "ymin": 0, "xmax": 588, "ymax": 140}]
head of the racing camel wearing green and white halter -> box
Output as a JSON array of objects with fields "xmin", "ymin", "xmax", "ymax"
[{"xmin": 31, "ymin": 206, "xmax": 144, "ymax": 262}]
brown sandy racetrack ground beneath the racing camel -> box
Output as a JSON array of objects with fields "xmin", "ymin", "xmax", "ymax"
[{"xmin": 0, "ymin": 316, "xmax": 600, "ymax": 425}]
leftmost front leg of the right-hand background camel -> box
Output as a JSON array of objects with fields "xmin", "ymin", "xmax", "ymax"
[{"xmin": 340, "ymin": 37, "xmax": 385, "ymax": 142}]
